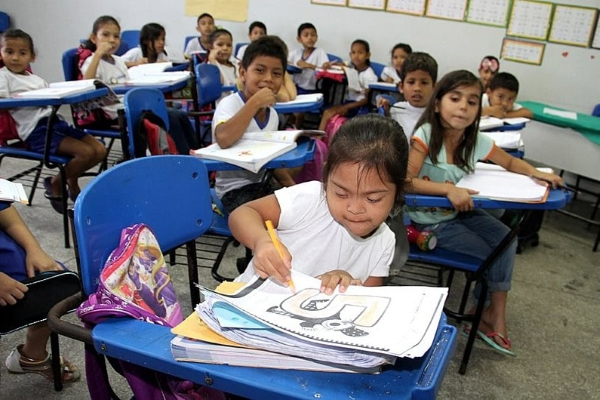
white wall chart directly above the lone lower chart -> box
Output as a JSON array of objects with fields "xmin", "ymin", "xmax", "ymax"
[{"xmin": 506, "ymin": 0, "xmax": 553, "ymax": 40}]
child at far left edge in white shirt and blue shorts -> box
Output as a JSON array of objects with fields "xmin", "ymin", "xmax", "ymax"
[{"xmin": 0, "ymin": 29, "xmax": 106, "ymax": 213}]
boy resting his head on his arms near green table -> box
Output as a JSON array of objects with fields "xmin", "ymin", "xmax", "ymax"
[{"xmin": 481, "ymin": 72, "xmax": 533, "ymax": 119}]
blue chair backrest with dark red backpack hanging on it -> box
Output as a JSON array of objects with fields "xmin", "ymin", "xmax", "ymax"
[{"xmin": 123, "ymin": 87, "xmax": 169, "ymax": 157}]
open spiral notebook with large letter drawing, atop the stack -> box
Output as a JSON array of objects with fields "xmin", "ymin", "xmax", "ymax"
[{"xmin": 199, "ymin": 270, "xmax": 447, "ymax": 361}]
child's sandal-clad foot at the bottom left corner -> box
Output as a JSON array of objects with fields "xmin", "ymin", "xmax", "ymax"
[{"xmin": 6, "ymin": 344, "xmax": 81, "ymax": 383}]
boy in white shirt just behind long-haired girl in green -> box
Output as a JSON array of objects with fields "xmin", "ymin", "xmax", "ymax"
[{"xmin": 377, "ymin": 52, "xmax": 438, "ymax": 141}]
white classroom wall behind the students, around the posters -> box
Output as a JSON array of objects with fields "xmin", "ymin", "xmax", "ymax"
[{"xmin": 0, "ymin": 0, "xmax": 600, "ymax": 113}]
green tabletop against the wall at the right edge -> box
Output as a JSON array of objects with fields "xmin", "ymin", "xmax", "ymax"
[{"xmin": 519, "ymin": 101, "xmax": 600, "ymax": 144}]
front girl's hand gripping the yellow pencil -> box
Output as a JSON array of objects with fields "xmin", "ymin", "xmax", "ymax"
[{"xmin": 253, "ymin": 236, "xmax": 292, "ymax": 284}]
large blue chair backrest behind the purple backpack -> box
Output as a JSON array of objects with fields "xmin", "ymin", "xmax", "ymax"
[{"xmin": 74, "ymin": 156, "xmax": 213, "ymax": 297}]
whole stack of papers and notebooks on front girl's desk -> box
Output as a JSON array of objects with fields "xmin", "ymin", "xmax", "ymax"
[{"xmin": 171, "ymin": 271, "xmax": 447, "ymax": 372}]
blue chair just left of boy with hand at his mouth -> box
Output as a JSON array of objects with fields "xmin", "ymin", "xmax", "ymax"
[{"xmin": 188, "ymin": 63, "xmax": 223, "ymax": 145}]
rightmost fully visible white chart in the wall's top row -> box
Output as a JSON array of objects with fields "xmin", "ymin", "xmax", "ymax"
[{"xmin": 548, "ymin": 4, "xmax": 598, "ymax": 47}]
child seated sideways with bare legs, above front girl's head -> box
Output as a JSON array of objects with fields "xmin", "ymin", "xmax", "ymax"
[{"xmin": 319, "ymin": 39, "xmax": 377, "ymax": 131}]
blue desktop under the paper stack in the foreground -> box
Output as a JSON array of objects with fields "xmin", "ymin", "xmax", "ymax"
[{"xmin": 92, "ymin": 315, "xmax": 456, "ymax": 400}]
